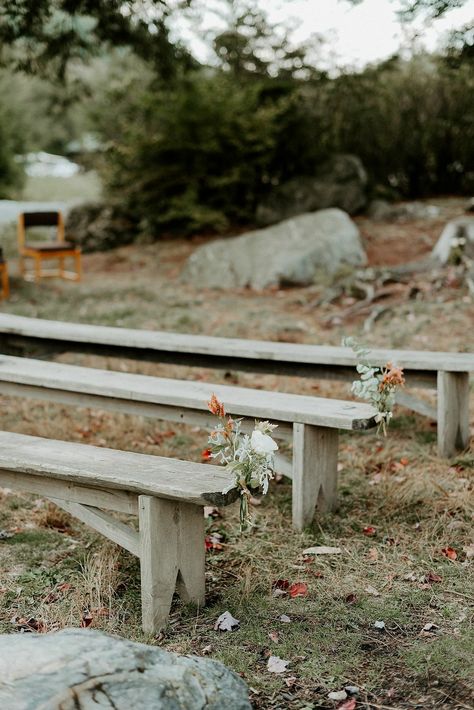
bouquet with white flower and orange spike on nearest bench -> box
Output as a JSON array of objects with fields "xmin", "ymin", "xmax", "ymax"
[{"xmin": 203, "ymin": 394, "xmax": 278, "ymax": 531}]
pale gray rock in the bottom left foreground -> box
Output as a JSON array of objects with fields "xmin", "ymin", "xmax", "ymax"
[{"xmin": 0, "ymin": 629, "xmax": 251, "ymax": 710}]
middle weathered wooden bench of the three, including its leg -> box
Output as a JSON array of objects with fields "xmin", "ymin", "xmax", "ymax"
[{"xmin": 0, "ymin": 355, "xmax": 376, "ymax": 530}]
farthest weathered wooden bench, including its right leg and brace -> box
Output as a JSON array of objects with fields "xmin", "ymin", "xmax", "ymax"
[{"xmin": 0, "ymin": 314, "xmax": 474, "ymax": 457}]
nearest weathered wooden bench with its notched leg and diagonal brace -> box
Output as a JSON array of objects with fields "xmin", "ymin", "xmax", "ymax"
[{"xmin": 0, "ymin": 431, "xmax": 238, "ymax": 633}]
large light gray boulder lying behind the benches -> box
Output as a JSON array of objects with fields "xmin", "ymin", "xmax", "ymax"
[{"xmin": 183, "ymin": 209, "xmax": 367, "ymax": 289}]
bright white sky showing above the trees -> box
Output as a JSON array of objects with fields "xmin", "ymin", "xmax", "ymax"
[{"xmin": 180, "ymin": 0, "xmax": 474, "ymax": 69}]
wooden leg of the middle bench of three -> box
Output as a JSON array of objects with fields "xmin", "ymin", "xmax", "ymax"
[{"xmin": 292, "ymin": 423, "xmax": 339, "ymax": 531}]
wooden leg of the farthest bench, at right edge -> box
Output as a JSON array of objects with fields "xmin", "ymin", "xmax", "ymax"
[{"xmin": 438, "ymin": 372, "xmax": 469, "ymax": 458}]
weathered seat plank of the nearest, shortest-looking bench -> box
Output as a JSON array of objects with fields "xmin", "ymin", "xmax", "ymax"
[{"xmin": 0, "ymin": 431, "xmax": 238, "ymax": 506}]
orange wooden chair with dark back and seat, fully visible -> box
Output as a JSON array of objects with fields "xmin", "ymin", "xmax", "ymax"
[{"xmin": 18, "ymin": 212, "xmax": 82, "ymax": 281}]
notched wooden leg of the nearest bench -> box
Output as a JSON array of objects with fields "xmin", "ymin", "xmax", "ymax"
[{"xmin": 138, "ymin": 496, "xmax": 205, "ymax": 634}]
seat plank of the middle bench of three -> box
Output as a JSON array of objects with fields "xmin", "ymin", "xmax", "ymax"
[{"xmin": 0, "ymin": 355, "xmax": 376, "ymax": 430}]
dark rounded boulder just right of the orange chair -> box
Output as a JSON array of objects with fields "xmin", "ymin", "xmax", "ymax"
[{"xmin": 66, "ymin": 202, "xmax": 137, "ymax": 252}]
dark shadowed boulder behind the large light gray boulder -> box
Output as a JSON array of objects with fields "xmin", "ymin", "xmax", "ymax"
[{"xmin": 257, "ymin": 155, "xmax": 367, "ymax": 225}]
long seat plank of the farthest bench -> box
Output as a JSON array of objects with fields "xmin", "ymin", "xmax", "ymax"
[{"xmin": 0, "ymin": 314, "xmax": 474, "ymax": 372}]
